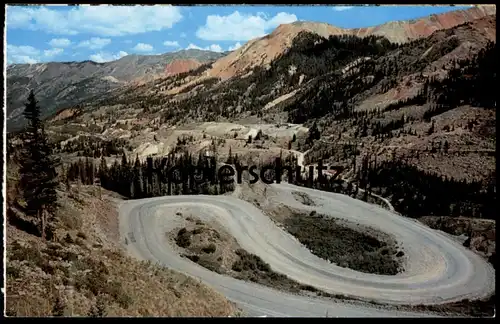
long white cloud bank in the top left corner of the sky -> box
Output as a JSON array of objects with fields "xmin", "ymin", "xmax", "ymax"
[{"xmin": 6, "ymin": 5, "xmax": 182, "ymax": 36}]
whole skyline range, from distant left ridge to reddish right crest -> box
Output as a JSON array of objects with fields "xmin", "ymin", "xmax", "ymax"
[{"xmin": 7, "ymin": 6, "xmax": 496, "ymax": 130}]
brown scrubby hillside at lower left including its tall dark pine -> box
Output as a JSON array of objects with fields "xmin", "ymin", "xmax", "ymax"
[{"xmin": 6, "ymin": 94, "xmax": 237, "ymax": 317}]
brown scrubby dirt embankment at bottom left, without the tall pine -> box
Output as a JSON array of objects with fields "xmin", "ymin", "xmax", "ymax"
[{"xmin": 6, "ymin": 182, "xmax": 237, "ymax": 317}]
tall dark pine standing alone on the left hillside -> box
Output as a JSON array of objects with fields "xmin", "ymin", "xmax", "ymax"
[{"xmin": 20, "ymin": 91, "xmax": 59, "ymax": 239}]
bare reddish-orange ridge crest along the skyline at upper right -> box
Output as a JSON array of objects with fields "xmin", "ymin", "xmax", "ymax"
[{"xmin": 208, "ymin": 5, "xmax": 496, "ymax": 79}]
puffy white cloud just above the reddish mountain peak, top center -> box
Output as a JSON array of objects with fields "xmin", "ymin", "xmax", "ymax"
[{"xmin": 196, "ymin": 11, "xmax": 297, "ymax": 41}]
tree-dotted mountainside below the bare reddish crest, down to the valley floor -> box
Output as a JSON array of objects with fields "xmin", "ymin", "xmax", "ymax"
[{"xmin": 34, "ymin": 15, "xmax": 496, "ymax": 195}]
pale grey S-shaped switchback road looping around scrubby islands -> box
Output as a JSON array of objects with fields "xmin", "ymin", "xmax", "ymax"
[{"xmin": 120, "ymin": 183, "xmax": 495, "ymax": 317}]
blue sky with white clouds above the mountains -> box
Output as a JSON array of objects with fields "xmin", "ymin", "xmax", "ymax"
[{"xmin": 6, "ymin": 5, "xmax": 472, "ymax": 64}]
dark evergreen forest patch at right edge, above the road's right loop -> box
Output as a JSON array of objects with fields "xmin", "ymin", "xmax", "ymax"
[{"xmin": 356, "ymin": 156, "xmax": 496, "ymax": 219}]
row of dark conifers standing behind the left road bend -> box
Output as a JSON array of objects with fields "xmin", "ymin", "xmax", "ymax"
[{"xmin": 65, "ymin": 149, "xmax": 234, "ymax": 199}]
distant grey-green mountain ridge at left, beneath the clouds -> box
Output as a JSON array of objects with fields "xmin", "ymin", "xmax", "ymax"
[{"xmin": 7, "ymin": 49, "xmax": 225, "ymax": 130}]
